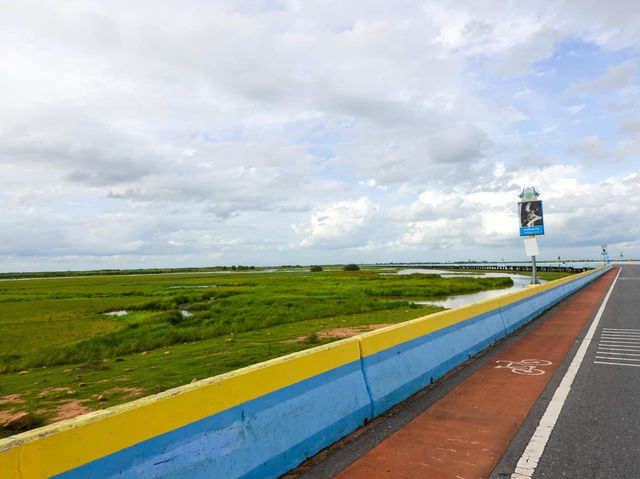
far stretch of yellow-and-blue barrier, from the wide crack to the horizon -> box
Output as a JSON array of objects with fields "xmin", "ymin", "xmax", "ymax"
[{"xmin": 360, "ymin": 269, "xmax": 605, "ymax": 416}]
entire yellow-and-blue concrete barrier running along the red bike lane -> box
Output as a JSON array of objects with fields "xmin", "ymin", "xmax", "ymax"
[{"xmin": 0, "ymin": 268, "xmax": 606, "ymax": 479}]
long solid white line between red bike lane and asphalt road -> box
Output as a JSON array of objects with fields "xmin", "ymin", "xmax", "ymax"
[{"xmin": 511, "ymin": 270, "xmax": 622, "ymax": 479}]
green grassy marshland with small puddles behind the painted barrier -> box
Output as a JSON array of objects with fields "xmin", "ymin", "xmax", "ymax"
[{"xmin": 0, "ymin": 270, "xmax": 560, "ymax": 436}]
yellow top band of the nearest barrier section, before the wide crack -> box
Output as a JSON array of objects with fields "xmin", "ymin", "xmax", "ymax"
[{"xmin": 0, "ymin": 338, "xmax": 360, "ymax": 479}]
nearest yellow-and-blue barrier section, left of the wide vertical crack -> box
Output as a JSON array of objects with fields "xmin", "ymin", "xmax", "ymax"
[{"xmin": 0, "ymin": 339, "xmax": 371, "ymax": 479}]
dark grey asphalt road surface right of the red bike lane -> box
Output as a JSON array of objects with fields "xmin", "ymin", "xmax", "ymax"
[{"xmin": 491, "ymin": 266, "xmax": 640, "ymax": 479}]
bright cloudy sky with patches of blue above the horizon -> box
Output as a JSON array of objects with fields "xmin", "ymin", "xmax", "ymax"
[{"xmin": 0, "ymin": 0, "xmax": 640, "ymax": 271}]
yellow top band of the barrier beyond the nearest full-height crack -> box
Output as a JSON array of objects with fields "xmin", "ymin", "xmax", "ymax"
[{"xmin": 360, "ymin": 267, "xmax": 602, "ymax": 357}]
